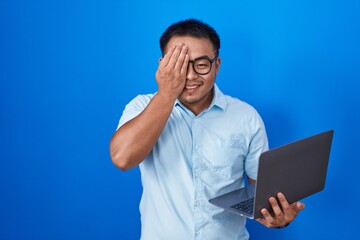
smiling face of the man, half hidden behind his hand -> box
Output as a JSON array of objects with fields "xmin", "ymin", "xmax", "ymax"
[{"xmin": 166, "ymin": 36, "xmax": 220, "ymax": 115}]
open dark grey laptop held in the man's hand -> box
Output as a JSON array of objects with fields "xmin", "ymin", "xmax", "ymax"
[{"xmin": 209, "ymin": 130, "xmax": 334, "ymax": 219}]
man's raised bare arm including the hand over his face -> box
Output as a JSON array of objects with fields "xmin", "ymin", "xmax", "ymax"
[{"xmin": 110, "ymin": 46, "xmax": 189, "ymax": 170}]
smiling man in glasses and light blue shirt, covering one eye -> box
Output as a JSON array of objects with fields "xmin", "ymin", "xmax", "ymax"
[{"xmin": 110, "ymin": 19, "xmax": 304, "ymax": 240}]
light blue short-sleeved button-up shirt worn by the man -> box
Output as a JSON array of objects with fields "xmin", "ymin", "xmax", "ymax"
[{"xmin": 119, "ymin": 84, "xmax": 268, "ymax": 240}]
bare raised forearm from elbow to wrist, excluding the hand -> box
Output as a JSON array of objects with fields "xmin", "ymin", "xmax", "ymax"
[{"xmin": 110, "ymin": 94, "xmax": 175, "ymax": 170}]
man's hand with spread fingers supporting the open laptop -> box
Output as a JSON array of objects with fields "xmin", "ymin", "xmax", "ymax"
[{"xmin": 256, "ymin": 193, "xmax": 305, "ymax": 228}]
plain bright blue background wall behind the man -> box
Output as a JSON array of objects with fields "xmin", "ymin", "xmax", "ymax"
[{"xmin": 0, "ymin": 0, "xmax": 360, "ymax": 239}]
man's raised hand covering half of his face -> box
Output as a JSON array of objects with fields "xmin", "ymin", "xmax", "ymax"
[{"xmin": 156, "ymin": 44, "xmax": 189, "ymax": 101}]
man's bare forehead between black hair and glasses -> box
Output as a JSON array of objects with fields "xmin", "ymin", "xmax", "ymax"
[{"xmin": 166, "ymin": 36, "xmax": 215, "ymax": 59}]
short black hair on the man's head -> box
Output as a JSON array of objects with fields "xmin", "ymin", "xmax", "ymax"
[{"xmin": 160, "ymin": 18, "xmax": 220, "ymax": 55}]
